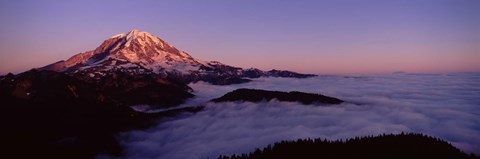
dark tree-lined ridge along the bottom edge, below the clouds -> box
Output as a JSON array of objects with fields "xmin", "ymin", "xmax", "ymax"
[{"xmin": 218, "ymin": 133, "xmax": 479, "ymax": 159}]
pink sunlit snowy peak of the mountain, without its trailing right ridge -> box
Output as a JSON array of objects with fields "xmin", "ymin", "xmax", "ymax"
[{"xmin": 46, "ymin": 30, "xmax": 200, "ymax": 73}]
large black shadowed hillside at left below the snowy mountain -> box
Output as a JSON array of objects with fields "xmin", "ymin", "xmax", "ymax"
[{"xmin": 0, "ymin": 70, "xmax": 201, "ymax": 159}]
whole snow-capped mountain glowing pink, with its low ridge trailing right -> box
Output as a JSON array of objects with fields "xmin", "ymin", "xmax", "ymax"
[{"xmin": 42, "ymin": 30, "xmax": 313, "ymax": 84}]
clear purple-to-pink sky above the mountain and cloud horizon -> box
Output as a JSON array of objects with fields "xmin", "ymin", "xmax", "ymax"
[{"xmin": 0, "ymin": 0, "xmax": 480, "ymax": 74}]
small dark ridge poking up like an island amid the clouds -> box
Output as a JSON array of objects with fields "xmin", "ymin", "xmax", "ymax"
[{"xmin": 212, "ymin": 88, "xmax": 344, "ymax": 104}]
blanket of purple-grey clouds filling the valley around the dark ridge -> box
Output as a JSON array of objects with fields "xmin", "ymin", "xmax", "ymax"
[{"xmin": 109, "ymin": 73, "xmax": 480, "ymax": 159}]
